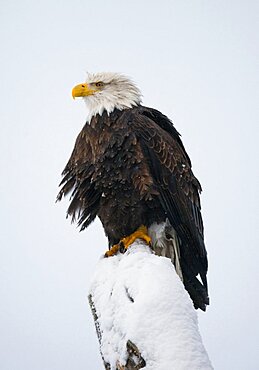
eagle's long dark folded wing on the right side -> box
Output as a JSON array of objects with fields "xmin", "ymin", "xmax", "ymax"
[{"xmin": 132, "ymin": 108, "xmax": 208, "ymax": 304}]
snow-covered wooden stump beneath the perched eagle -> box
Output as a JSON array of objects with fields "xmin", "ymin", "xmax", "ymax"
[{"xmin": 89, "ymin": 240, "xmax": 213, "ymax": 370}]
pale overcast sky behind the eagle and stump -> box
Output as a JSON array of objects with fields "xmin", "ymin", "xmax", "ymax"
[{"xmin": 0, "ymin": 0, "xmax": 259, "ymax": 370}]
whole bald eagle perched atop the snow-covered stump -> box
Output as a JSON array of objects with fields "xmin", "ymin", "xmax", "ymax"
[{"xmin": 57, "ymin": 73, "xmax": 209, "ymax": 311}]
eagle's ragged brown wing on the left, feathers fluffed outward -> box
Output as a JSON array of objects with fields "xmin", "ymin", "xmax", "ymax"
[{"xmin": 57, "ymin": 125, "xmax": 101, "ymax": 229}]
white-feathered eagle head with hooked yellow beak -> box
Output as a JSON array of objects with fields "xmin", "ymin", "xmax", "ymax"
[{"xmin": 72, "ymin": 72, "xmax": 141, "ymax": 120}]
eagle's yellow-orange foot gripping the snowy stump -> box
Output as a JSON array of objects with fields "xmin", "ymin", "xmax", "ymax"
[{"xmin": 104, "ymin": 225, "xmax": 151, "ymax": 257}]
